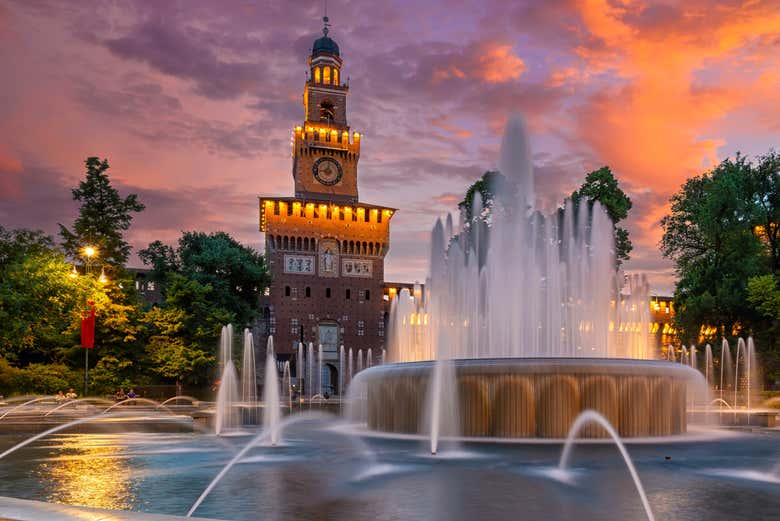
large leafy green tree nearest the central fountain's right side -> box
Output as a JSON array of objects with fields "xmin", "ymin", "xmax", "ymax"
[{"xmin": 661, "ymin": 155, "xmax": 769, "ymax": 342}]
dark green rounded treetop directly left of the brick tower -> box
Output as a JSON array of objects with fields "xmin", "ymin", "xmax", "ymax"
[{"xmin": 138, "ymin": 232, "xmax": 270, "ymax": 324}]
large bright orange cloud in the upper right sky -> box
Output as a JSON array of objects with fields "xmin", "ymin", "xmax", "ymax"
[{"xmin": 576, "ymin": 0, "xmax": 780, "ymax": 193}]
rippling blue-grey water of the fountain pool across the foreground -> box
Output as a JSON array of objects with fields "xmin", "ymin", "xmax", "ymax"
[{"xmin": 0, "ymin": 418, "xmax": 780, "ymax": 521}]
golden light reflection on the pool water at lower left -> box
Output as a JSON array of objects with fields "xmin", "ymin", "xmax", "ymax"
[{"xmin": 37, "ymin": 435, "xmax": 135, "ymax": 510}]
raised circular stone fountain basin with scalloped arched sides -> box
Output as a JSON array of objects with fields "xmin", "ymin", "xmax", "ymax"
[{"xmin": 360, "ymin": 358, "xmax": 701, "ymax": 438}]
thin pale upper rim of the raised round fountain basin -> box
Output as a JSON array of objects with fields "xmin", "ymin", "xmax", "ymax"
[{"xmin": 358, "ymin": 357, "xmax": 702, "ymax": 380}]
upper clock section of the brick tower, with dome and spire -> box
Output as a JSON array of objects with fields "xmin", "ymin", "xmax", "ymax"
[{"xmin": 293, "ymin": 17, "xmax": 360, "ymax": 203}]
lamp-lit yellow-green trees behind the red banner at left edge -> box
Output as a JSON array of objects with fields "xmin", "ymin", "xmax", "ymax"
[{"xmin": 0, "ymin": 223, "xmax": 145, "ymax": 389}]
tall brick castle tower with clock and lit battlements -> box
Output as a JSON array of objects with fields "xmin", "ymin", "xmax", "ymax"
[{"xmin": 260, "ymin": 17, "xmax": 395, "ymax": 393}]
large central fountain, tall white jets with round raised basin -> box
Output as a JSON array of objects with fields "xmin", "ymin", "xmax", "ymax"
[{"xmin": 353, "ymin": 115, "xmax": 702, "ymax": 438}]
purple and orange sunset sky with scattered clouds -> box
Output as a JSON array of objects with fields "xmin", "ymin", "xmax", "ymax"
[{"xmin": 0, "ymin": 0, "xmax": 780, "ymax": 294}]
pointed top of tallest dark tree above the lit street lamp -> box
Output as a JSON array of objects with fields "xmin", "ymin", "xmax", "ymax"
[{"xmin": 59, "ymin": 157, "xmax": 144, "ymax": 266}]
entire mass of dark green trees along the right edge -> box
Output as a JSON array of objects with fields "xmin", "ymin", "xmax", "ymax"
[{"xmin": 660, "ymin": 151, "xmax": 780, "ymax": 380}]
